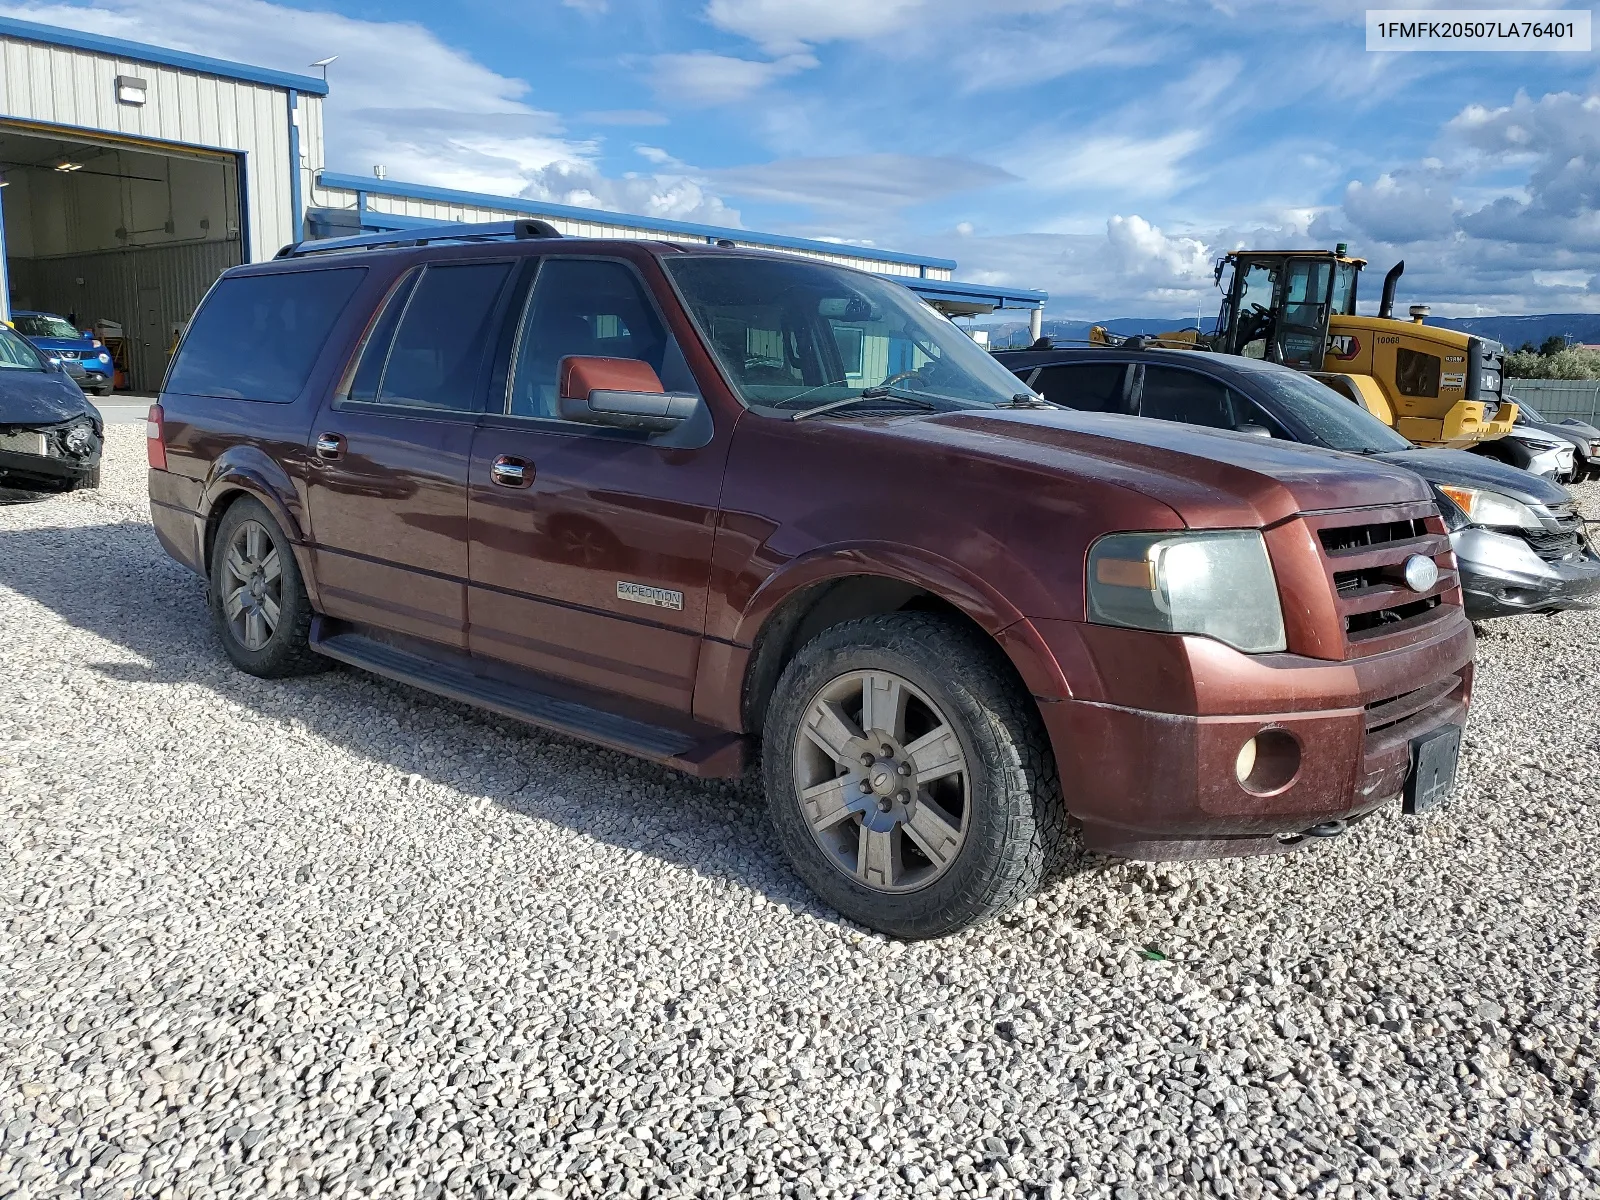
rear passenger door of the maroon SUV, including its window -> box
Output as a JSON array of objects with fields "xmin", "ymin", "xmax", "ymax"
[{"xmin": 307, "ymin": 259, "xmax": 514, "ymax": 650}]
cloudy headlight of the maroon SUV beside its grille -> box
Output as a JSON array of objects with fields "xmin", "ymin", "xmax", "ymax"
[{"xmin": 1088, "ymin": 530, "xmax": 1288, "ymax": 654}]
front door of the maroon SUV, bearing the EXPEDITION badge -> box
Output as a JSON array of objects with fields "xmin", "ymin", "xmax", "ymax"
[{"xmin": 467, "ymin": 254, "xmax": 728, "ymax": 712}]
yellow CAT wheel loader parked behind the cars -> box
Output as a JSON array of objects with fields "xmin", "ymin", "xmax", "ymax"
[{"xmin": 1090, "ymin": 243, "xmax": 1517, "ymax": 446}]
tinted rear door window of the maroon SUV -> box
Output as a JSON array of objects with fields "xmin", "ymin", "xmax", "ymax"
[{"xmin": 347, "ymin": 262, "xmax": 510, "ymax": 413}]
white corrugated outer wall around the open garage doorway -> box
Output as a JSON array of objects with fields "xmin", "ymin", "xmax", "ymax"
[{"xmin": 0, "ymin": 37, "xmax": 299, "ymax": 261}]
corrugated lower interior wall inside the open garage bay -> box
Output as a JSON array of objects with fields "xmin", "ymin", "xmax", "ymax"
[{"xmin": 10, "ymin": 242, "xmax": 240, "ymax": 392}]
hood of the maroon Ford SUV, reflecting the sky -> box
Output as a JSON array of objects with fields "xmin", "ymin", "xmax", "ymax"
[{"xmin": 893, "ymin": 408, "xmax": 1434, "ymax": 528}]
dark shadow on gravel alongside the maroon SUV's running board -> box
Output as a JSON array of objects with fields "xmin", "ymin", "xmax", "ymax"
[{"xmin": 0, "ymin": 523, "xmax": 876, "ymax": 920}]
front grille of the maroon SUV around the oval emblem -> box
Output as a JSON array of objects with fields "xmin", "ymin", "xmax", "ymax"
[{"xmin": 1302, "ymin": 501, "xmax": 1461, "ymax": 659}]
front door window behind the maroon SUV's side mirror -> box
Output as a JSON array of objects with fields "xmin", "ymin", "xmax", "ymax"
[{"xmin": 507, "ymin": 254, "xmax": 699, "ymax": 419}]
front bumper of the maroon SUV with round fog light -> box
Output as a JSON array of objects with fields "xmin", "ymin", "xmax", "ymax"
[{"xmin": 1040, "ymin": 616, "xmax": 1474, "ymax": 859}]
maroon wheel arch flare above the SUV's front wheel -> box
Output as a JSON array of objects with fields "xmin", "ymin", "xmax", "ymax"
[{"xmin": 734, "ymin": 541, "xmax": 1072, "ymax": 699}]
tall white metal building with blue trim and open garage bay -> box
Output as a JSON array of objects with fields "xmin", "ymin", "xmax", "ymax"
[{"xmin": 0, "ymin": 18, "xmax": 328, "ymax": 389}]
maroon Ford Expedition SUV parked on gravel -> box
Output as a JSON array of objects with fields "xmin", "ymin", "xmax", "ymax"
[{"xmin": 149, "ymin": 222, "xmax": 1472, "ymax": 936}]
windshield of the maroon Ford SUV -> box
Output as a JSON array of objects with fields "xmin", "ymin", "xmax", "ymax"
[{"xmin": 666, "ymin": 254, "xmax": 1022, "ymax": 411}]
